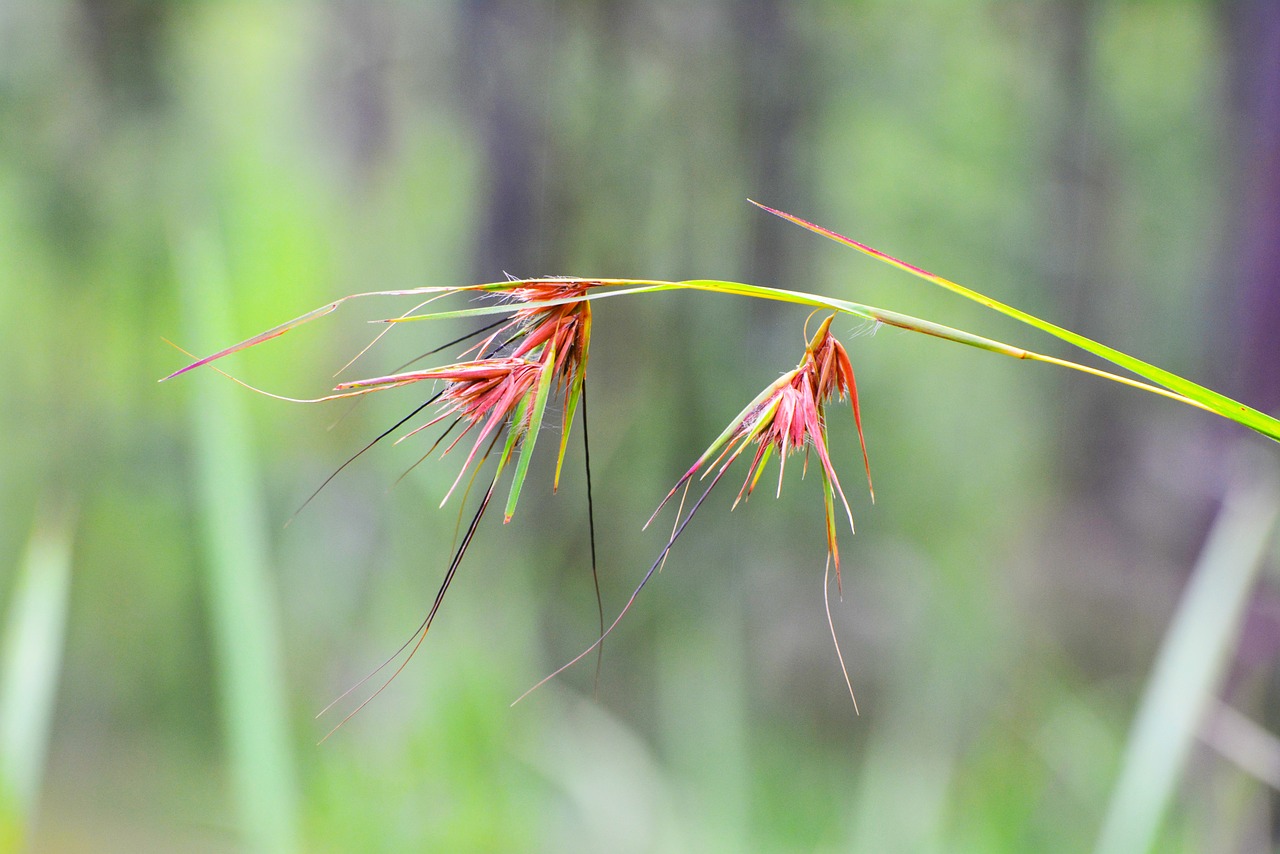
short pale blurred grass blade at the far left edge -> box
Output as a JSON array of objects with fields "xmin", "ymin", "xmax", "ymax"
[{"xmin": 0, "ymin": 510, "xmax": 72, "ymax": 851}]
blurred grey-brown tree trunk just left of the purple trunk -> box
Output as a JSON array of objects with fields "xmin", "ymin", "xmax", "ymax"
[{"xmin": 1041, "ymin": 0, "xmax": 1170, "ymax": 676}]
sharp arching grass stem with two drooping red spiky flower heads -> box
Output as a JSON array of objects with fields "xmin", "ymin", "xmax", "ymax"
[{"xmin": 164, "ymin": 202, "xmax": 1280, "ymax": 722}]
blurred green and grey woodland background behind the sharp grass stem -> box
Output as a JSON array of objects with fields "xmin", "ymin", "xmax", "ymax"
[{"xmin": 0, "ymin": 0, "xmax": 1280, "ymax": 851}]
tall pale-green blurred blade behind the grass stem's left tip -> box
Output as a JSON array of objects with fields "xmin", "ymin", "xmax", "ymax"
[{"xmin": 174, "ymin": 229, "xmax": 298, "ymax": 854}]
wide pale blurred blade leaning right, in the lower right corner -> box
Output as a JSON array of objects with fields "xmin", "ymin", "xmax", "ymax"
[{"xmin": 1094, "ymin": 448, "xmax": 1280, "ymax": 854}]
